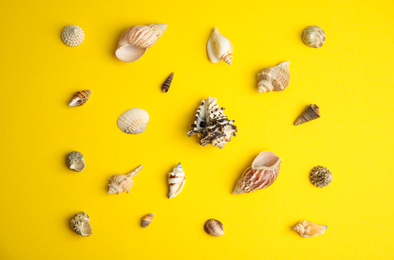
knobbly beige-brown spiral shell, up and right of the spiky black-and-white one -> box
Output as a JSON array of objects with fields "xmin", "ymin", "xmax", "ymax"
[{"xmin": 257, "ymin": 61, "xmax": 290, "ymax": 93}]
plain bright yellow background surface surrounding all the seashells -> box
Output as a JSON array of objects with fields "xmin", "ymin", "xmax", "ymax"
[{"xmin": 0, "ymin": 0, "xmax": 394, "ymax": 260}]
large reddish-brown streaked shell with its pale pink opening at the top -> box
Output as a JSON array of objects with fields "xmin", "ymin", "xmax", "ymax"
[{"xmin": 233, "ymin": 151, "xmax": 282, "ymax": 194}]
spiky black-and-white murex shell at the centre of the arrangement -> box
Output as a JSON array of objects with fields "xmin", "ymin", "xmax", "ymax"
[{"xmin": 188, "ymin": 97, "xmax": 237, "ymax": 148}]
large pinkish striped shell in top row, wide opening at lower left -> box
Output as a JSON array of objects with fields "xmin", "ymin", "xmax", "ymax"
[{"xmin": 115, "ymin": 24, "xmax": 167, "ymax": 62}]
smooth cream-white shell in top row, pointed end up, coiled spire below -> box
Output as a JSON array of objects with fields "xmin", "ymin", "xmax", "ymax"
[{"xmin": 207, "ymin": 27, "xmax": 233, "ymax": 65}]
